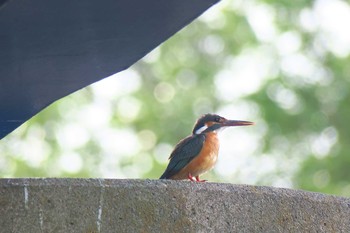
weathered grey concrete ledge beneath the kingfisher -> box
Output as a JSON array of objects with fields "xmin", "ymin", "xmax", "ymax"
[{"xmin": 0, "ymin": 179, "xmax": 350, "ymax": 233}]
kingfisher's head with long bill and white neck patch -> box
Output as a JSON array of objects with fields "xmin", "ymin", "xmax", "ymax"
[{"xmin": 192, "ymin": 114, "xmax": 254, "ymax": 134}]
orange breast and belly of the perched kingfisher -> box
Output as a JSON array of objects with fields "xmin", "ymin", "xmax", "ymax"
[{"xmin": 171, "ymin": 132, "xmax": 219, "ymax": 179}]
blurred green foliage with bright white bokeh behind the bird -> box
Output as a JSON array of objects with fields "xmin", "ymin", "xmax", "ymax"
[{"xmin": 0, "ymin": 0, "xmax": 350, "ymax": 196}]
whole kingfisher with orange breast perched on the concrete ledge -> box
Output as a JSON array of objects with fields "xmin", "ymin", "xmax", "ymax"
[{"xmin": 159, "ymin": 113, "xmax": 254, "ymax": 182}]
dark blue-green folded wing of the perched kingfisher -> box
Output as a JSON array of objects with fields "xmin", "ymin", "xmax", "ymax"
[{"xmin": 160, "ymin": 134, "xmax": 205, "ymax": 179}]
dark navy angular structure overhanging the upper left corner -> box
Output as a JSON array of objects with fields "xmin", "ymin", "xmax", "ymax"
[{"xmin": 0, "ymin": 0, "xmax": 218, "ymax": 139}]
